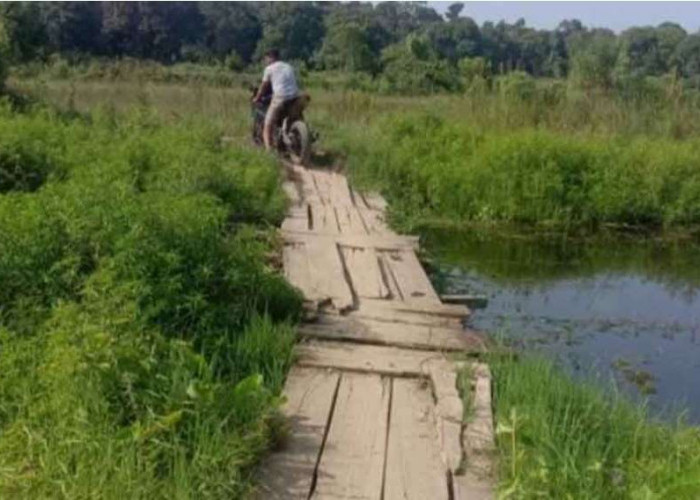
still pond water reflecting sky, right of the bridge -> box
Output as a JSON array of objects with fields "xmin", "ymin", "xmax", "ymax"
[{"xmin": 425, "ymin": 231, "xmax": 700, "ymax": 423}]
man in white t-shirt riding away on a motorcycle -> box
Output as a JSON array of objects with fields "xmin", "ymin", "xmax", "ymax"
[{"xmin": 253, "ymin": 49, "xmax": 299, "ymax": 150}]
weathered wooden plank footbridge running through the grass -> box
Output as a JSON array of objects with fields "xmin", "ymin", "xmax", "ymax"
[{"xmin": 259, "ymin": 166, "xmax": 493, "ymax": 500}]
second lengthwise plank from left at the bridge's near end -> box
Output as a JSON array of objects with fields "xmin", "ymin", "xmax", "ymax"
[{"xmin": 313, "ymin": 373, "xmax": 390, "ymax": 500}]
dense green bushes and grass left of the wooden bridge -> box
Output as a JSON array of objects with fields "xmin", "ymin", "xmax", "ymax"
[{"xmin": 0, "ymin": 101, "xmax": 300, "ymax": 498}]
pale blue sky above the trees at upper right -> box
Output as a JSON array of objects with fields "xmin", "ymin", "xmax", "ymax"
[{"xmin": 428, "ymin": 0, "xmax": 700, "ymax": 33}]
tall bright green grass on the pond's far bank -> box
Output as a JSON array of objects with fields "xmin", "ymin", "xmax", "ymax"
[{"xmin": 336, "ymin": 114, "xmax": 700, "ymax": 227}]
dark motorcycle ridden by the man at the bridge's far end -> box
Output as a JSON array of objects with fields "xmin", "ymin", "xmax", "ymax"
[{"xmin": 251, "ymin": 87, "xmax": 316, "ymax": 165}]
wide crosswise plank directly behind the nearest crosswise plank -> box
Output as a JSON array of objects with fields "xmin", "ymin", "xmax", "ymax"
[{"xmin": 299, "ymin": 314, "xmax": 486, "ymax": 352}]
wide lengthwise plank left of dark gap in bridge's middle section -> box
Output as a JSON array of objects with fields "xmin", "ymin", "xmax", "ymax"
[{"xmin": 306, "ymin": 240, "xmax": 354, "ymax": 311}]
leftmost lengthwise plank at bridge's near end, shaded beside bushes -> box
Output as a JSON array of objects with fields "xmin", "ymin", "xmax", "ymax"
[{"xmin": 256, "ymin": 367, "xmax": 339, "ymax": 500}]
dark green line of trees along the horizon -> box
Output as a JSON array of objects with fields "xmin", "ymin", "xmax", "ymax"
[{"xmin": 0, "ymin": 2, "xmax": 700, "ymax": 88}]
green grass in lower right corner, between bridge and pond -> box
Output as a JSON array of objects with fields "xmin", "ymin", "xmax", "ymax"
[{"xmin": 491, "ymin": 357, "xmax": 700, "ymax": 499}]
